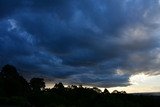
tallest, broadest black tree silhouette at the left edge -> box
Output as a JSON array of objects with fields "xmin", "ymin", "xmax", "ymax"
[{"xmin": 0, "ymin": 65, "xmax": 30, "ymax": 96}]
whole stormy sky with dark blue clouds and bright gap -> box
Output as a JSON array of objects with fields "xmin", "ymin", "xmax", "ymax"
[{"xmin": 0, "ymin": 0, "xmax": 160, "ymax": 92}]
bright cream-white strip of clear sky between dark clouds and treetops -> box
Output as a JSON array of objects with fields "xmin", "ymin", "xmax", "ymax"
[{"xmin": 46, "ymin": 73, "xmax": 160, "ymax": 93}]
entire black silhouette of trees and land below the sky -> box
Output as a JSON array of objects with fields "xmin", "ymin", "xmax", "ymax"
[{"xmin": 0, "ymin": 65, "xmax": 160, "ymax": 107}]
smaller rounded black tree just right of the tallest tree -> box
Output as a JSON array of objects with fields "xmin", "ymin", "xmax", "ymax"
[{"xmin": 30, "ymin": 78, "xmax": 45, "ymax": 92}]
